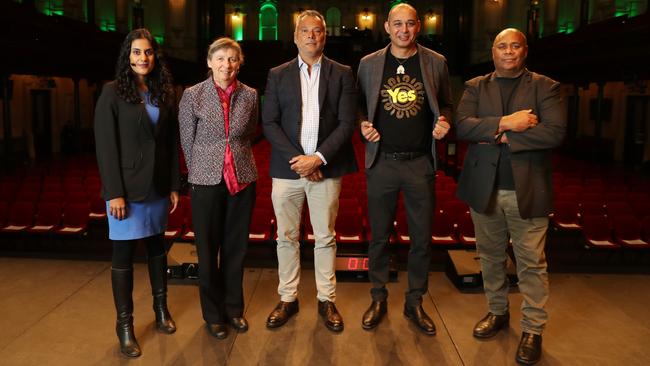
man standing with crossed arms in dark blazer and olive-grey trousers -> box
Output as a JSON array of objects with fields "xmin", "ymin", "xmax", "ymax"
[{"xmin": 456, "ymin": 28, "xmax": 566, "ymax": 364}]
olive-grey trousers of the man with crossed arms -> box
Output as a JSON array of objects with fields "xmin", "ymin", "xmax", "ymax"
[{"xmin": 471, "ymin": 190, "xmax": 549, "ymax": 334}]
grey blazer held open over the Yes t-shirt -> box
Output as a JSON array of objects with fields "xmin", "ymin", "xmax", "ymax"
[{"xmin": 357, "ymin": 44, "xmax": 452, "ymax": 169}]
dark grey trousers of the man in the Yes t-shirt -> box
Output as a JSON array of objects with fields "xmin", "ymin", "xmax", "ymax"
[{"xmin": 366, "ymin": 155, "xmax": 435, "ymax": 306}]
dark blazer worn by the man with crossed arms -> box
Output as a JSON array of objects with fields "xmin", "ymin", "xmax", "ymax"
[{"xmin": 456, "ymin": 70, "xmax": 566, "ymax": 219}]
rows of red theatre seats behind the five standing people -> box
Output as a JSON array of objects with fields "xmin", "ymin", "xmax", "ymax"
[{"xmin": 0, "ymin": 143, "xmax": 650, "ymax": 249}]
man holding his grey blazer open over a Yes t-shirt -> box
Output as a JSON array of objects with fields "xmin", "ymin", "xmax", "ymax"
[{"xmin": 358, "ymin": 4, "xmax": 451, "ymax": 335}]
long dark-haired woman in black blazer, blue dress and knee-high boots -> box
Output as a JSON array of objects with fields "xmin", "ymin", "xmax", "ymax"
[{"xmin": 95, "ymin": 29, "xmax": 180, "ymax": 357}]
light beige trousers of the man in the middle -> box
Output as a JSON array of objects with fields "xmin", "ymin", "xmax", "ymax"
[{"xmin": 271, "ymin": 178, "xmax": 341, "ymax": 302}]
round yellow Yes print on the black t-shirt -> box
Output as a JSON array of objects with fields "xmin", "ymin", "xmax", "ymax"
[{"xmin": 381, "ymin": 75, "xmax": 424, "ymax": 119}]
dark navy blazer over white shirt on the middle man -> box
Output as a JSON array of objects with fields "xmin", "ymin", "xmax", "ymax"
[{"xmin": 262, "ymin": 56, "xmax": 357, "ymax": 179}]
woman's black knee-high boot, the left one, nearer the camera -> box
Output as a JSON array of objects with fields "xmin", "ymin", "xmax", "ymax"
[{"xmin": 111, "ymin": 268, "xmax": 142, "ymax": 357}]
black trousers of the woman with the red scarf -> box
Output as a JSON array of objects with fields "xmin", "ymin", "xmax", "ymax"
[{"xmin": 192, "ymin": 182, "xmax": 255, "ymax": 324}]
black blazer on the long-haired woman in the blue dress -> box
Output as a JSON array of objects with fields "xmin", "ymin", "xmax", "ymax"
[{"xmin": 95, "ymin": 81, "xmax": 180, "ymax": 201}]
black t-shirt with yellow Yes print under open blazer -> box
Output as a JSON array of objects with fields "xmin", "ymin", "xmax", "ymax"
[{"xmin": 373, "ymin": 52, "xmax": 433, "ymax": 153}]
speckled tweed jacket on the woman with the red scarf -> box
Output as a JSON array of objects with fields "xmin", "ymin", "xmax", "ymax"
[{"xmin": 178, "ymin": 77, "xmax": 258, "ymax": 185}]
